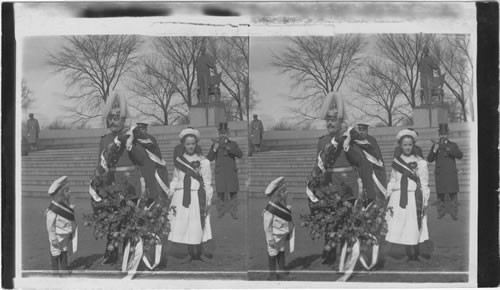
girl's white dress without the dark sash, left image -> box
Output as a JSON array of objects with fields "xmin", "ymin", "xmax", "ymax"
[{"xmin": 168, "ymin": 154, "xmax": 213, "ymax": 245}]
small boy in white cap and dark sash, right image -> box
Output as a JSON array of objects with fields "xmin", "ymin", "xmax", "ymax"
[{"xmin": 263, "ymin": 177, "xmax": 295, "ymax": 280}]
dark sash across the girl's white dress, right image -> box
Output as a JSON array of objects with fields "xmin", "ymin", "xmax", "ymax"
[{"xmin": 392, "ymin": 156, "xmax": 424, "ymax": 229}]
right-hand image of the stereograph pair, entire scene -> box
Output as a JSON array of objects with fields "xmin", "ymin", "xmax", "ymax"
[{"xmin": 247, "ymin": 33, "xmax": 476, "ymax": 283}]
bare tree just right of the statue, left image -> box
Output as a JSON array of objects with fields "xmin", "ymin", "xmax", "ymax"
[{"xmin": 209, "ymin": 37, "xmax": 255, "ymax": 120}]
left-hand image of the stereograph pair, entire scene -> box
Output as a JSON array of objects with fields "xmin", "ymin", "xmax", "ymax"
[{"xmin": 17, "ymin": 34, "xmax": 250, "ymax": 280}]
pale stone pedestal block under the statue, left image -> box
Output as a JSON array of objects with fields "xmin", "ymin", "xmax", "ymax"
[{"xmin": 189, "ymin": 103, "xmax": 226, "ymax": 127}]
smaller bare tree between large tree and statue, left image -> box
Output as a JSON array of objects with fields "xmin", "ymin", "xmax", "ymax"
[{"xmin": 129, "ymin": 57, "xmax": 188, "ymax": 125}]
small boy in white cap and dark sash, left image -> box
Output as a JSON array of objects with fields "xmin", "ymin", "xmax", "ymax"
[{"xmin": 45, "ymin": 176, "xmax": 77, "ymax": 271}]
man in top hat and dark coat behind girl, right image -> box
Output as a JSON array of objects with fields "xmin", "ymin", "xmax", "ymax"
[{"xmin": 427, "ymin": 123, "xmax": 463, "ymax": 220}]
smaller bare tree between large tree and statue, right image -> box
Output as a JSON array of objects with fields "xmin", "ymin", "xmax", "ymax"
[{"xmin": 349, "ymin": 60, "xmax": 410, "ymax": 127}]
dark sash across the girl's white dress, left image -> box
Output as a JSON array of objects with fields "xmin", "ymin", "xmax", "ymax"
[{"xmin": 174, "ymin": 156, "xmax": 207, "ymax": 229}]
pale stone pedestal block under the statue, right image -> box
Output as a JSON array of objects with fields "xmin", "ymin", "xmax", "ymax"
[{"xmin": 413, "ymin": 104, "xmax": 448, "ymax": 128}]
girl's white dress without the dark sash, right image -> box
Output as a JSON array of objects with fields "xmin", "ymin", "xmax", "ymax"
[{"xmin": 386, "ymin": 155, "xmax": 430, "ymax": 245}]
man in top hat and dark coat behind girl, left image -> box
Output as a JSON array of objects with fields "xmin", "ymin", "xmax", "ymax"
[{"xmin": 207, "ymin": 123, "xmax": 243, "ymax": 219}]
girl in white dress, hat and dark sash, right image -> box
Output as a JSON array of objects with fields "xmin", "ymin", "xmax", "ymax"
[{"xmin": 386, "ymin": 129, "xmax": 430, "ymax": 260}]
